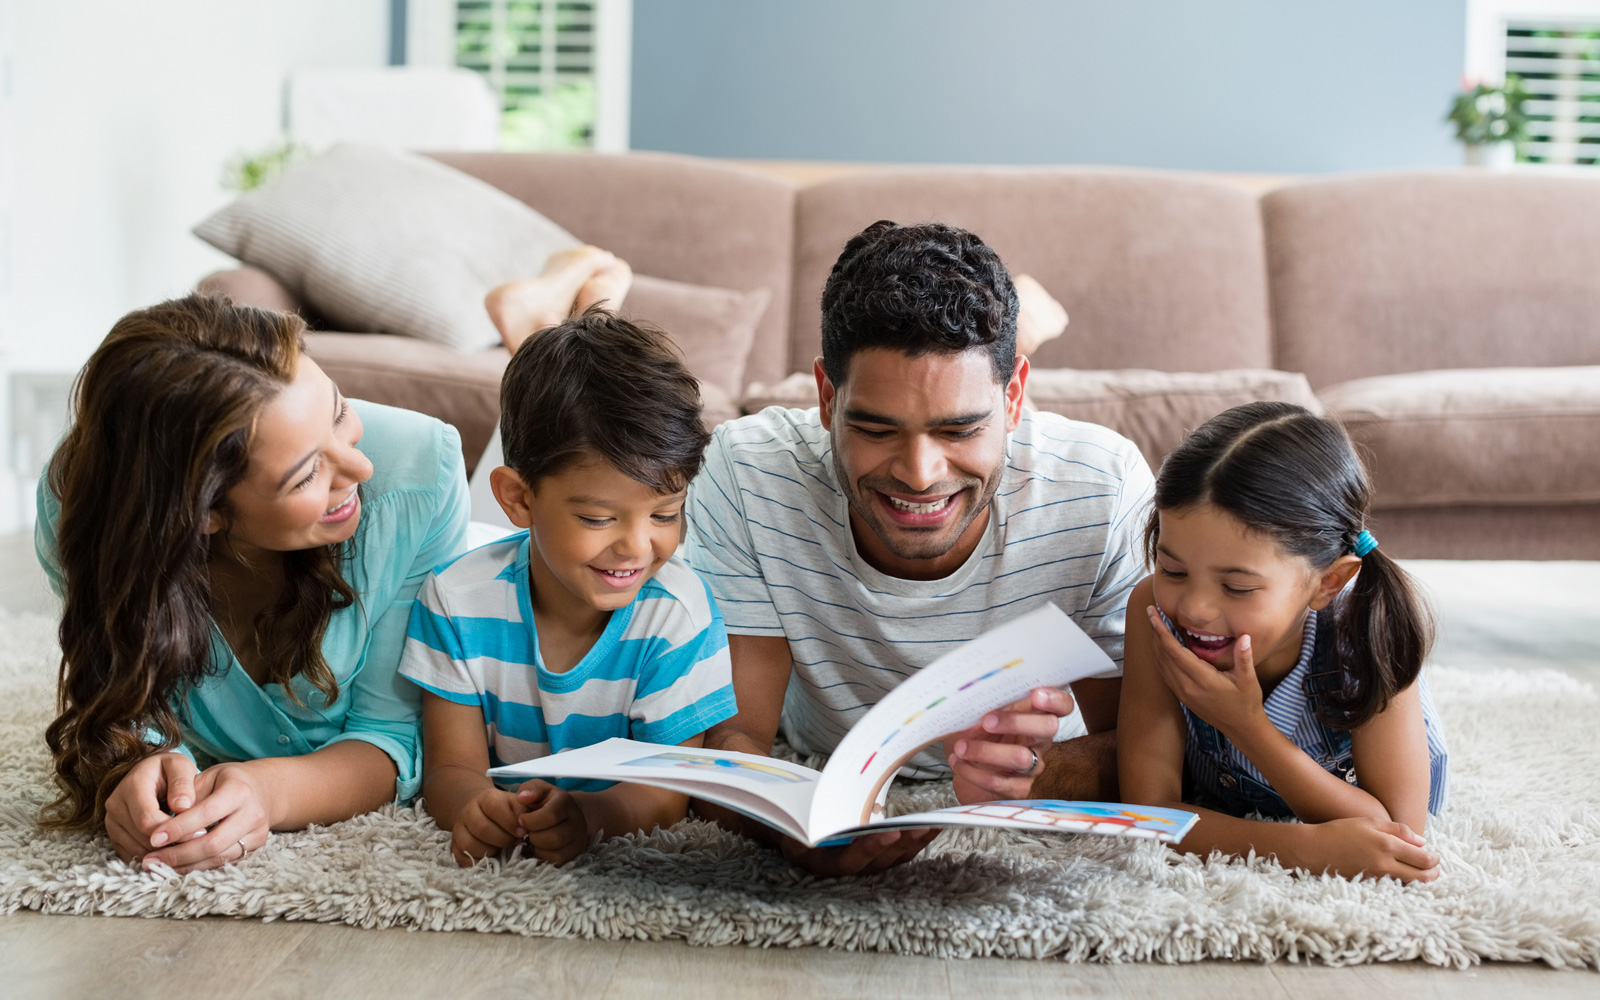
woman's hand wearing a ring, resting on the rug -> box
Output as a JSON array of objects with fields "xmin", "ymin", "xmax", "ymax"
[{"xmin": 144, "ymin": 763, "xmax": 272, "ymax": 875}]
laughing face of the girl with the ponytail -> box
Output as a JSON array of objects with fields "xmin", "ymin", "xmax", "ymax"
[{"xmin": 1152, "ymin": 504, "xmax": 1350, "ymax": 675}]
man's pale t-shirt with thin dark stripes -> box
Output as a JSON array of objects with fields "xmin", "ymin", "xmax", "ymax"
[{"xmin": 683, "ymin": 406, "xmax": 1152, "ymax": 778}]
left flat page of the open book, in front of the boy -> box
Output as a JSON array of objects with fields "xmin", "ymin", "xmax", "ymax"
[{"xmin": 488, "ymin": 738, "xmax": 821, "ymax": 840}]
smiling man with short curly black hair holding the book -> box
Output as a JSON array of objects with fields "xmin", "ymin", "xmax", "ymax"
[{"xmin": 685, "ymin": 222, "xmax": 1152, "ymax": 874}]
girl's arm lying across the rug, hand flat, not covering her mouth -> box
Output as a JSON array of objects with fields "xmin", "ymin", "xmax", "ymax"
[{"xmin": 1117, "ymin": 579, "xmax": 1438, "ymax": 880}]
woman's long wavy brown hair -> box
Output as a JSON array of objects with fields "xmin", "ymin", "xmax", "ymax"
[{"xmin": 42, "ymin": 294, "xmax": 355, "ymax": 829}]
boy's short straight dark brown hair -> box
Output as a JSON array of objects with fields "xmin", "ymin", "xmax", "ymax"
[{"xmin": 501, "ymin": 307, "xmax": 710, "ymax": 493}]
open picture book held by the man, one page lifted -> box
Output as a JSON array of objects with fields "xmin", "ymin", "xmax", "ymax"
[{"xmin": 490, "ymin": 603, "xmax": 1198, "ymax": 845}]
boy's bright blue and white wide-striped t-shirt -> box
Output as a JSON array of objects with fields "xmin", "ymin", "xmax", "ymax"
[{"xmin": 400, "ymin": 531, "xmax": 736, "ymax": 790}]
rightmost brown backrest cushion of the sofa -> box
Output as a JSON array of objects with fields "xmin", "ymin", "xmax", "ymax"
[{"xmin": 1260, "ymin": 170, "xmax": 1600, "ymax": 392}]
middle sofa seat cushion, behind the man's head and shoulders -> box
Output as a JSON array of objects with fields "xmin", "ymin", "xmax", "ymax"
[{"xmin": 741, "ymin": 368, "xmax": 1323, "ymax": 469}]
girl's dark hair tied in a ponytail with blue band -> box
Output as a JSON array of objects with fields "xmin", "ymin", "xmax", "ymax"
[{"xmin": 1144, "ymin": 403, "xmax": 1434, "ymax": 730}]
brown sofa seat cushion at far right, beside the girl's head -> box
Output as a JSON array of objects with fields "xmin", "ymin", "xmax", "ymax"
[{"xmin": 1320, "ymin": 366, "xmax": 1600, "ymax": 509}]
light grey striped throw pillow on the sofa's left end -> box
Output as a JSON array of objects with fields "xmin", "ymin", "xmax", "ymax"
[{"xmin": 194, "ymin": 144, "xmax": 579, "ymax": 352}]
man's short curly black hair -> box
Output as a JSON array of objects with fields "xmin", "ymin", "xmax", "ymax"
[{"xmin": 822, "ymin": 219, "xmax": 1018, "ymax": 386}]
